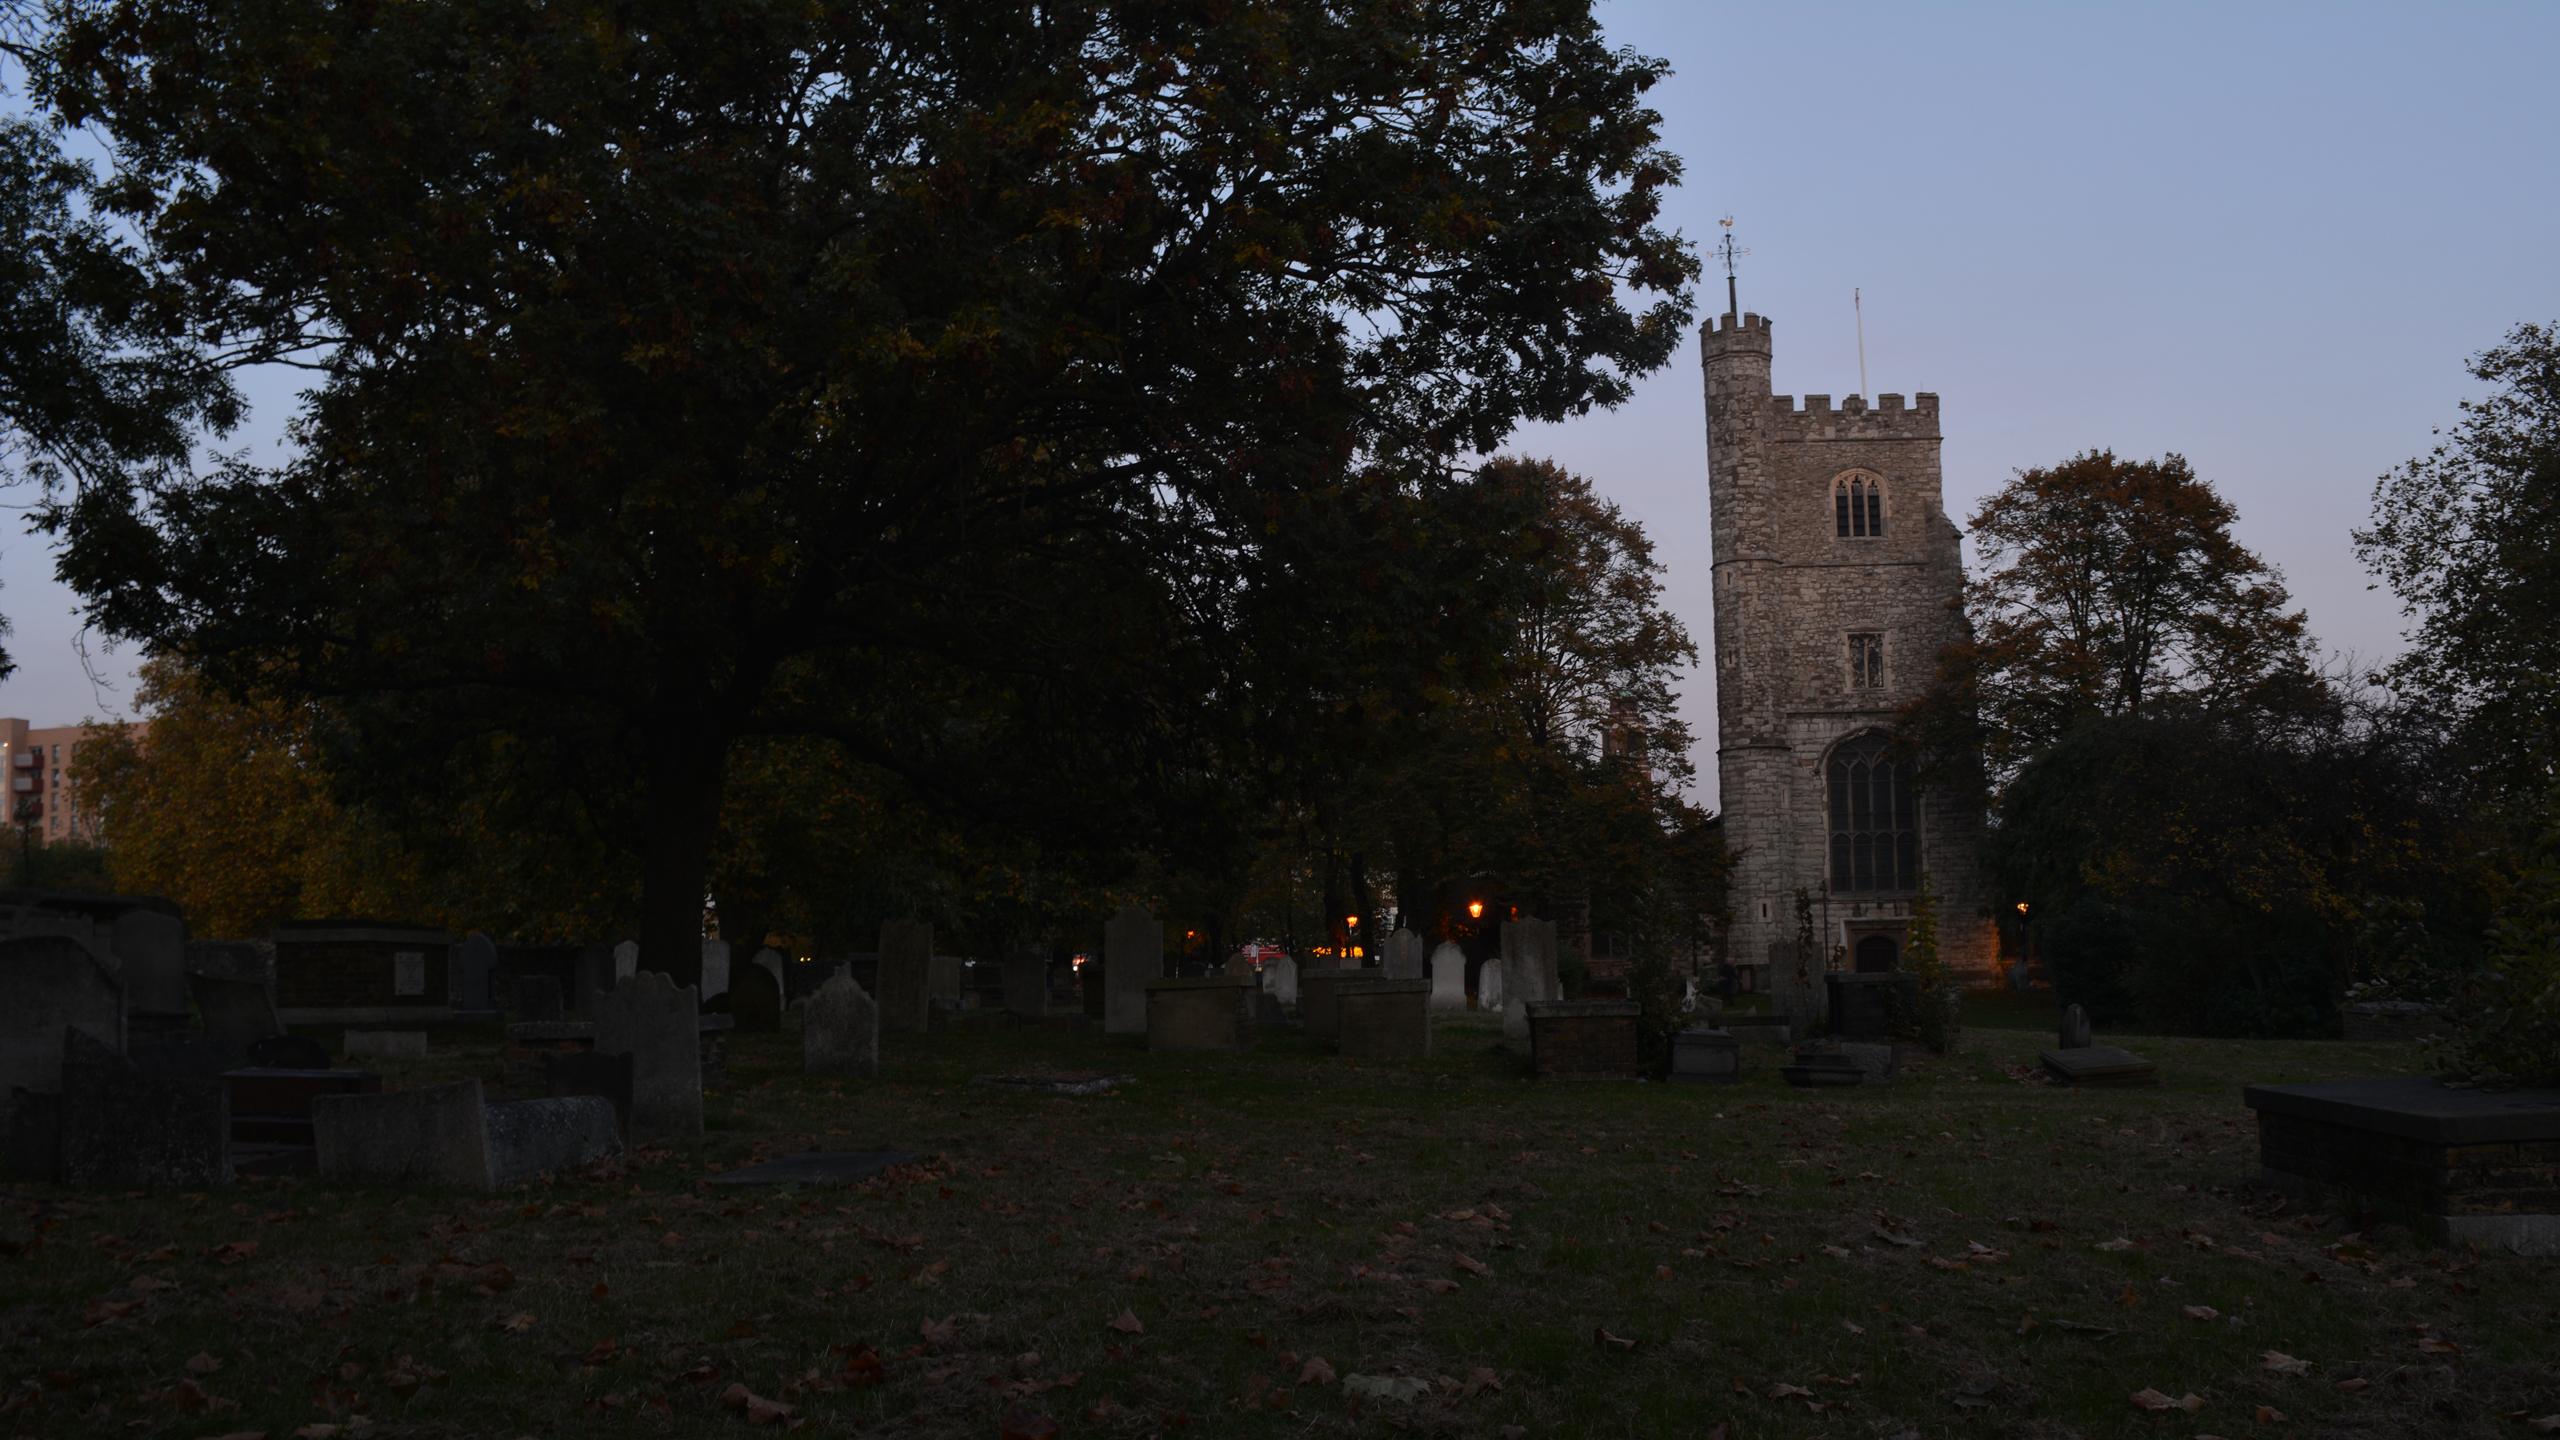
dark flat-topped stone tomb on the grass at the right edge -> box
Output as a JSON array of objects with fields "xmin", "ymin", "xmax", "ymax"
[{"xmin": 2240, "ymin": 1079, "xmax": 2560, "ymax": 1256}]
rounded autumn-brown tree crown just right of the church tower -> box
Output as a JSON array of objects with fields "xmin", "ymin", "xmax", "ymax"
[{"xmin": 1902, "ymin": 451, "xmax": 2327, "ymax": 784}]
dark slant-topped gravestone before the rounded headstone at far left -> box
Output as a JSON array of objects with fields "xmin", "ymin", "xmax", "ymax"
[{"xmin": 59, "ymin": 1030, "xmax": 230, "ymax": 1189}]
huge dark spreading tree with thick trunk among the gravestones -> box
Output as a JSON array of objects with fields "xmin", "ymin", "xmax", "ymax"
[{"xmin": 36, "ymin": 0, "xmax": 1695, "ymax": 976}]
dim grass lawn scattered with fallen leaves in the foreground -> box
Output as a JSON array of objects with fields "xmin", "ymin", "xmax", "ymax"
[{"xmin": 0, "ymin": 1004, "xmax": 2560, "ymax": 1440}]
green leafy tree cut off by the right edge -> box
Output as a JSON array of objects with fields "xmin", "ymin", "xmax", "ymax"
[{"xmin": 2355, "ymin": 325, "xmax": 2560, "ymax": 789}]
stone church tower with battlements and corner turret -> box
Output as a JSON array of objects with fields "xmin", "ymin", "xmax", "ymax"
[{"xmin": 1700, "ymin": 302, "xmax": 1997, "ymax": 979}]
